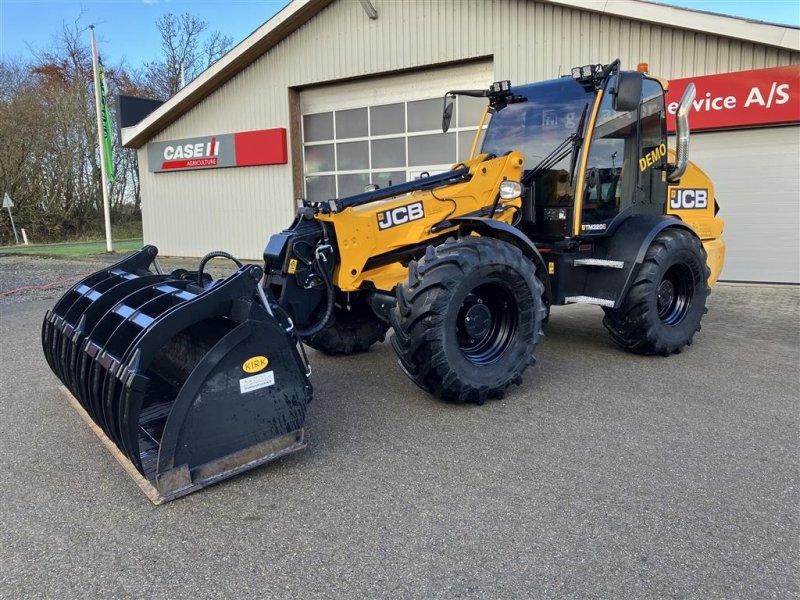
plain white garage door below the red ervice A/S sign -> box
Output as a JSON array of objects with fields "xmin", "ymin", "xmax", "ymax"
[{"xmin": 690, "ymin": 126, "xmax": 800, "ymax": 283}]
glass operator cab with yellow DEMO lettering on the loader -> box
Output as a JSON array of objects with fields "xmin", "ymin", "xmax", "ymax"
[{"xmin": 481, "ymin": 65, "xmax": 667, "ymax": 243}]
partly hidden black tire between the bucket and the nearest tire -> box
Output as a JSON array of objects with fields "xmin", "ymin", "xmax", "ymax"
[{"xmin": 303, "ymin": 302, "xmax": 389, "ymax": 356}]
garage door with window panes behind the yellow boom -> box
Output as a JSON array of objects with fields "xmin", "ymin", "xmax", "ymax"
[{"xmin": 300, "ymin": 61, "xmax": 494, "ymax": 200}]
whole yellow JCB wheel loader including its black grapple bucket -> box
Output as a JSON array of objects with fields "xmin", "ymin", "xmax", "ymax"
[{"xmin": 42, "ymin": 60, "xmax": 725, "ymax": 502}]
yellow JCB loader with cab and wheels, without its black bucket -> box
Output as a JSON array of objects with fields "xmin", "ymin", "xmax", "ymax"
[{"xmin": 264, "ymin": 64, "xmax": 724, "ymax": 402}]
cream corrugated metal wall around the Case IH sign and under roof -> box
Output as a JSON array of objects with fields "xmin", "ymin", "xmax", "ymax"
[{"xmin": 139, "ymin": 0, "xmax": 800, "ymax": 259}]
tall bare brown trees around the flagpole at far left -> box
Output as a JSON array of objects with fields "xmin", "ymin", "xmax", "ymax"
[{"xmin": 0, "ymin": 24, "xmax": 139, "ymax": 241}]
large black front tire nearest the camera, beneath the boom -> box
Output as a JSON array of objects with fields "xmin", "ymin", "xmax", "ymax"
[{"xmin": 390, "ymin": 237, "xmax": 545, "ymax": 404}]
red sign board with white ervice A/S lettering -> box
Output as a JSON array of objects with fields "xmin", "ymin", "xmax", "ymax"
[{"xmin": 667, "ymin": 65, "xmax": 800, "ymax": 132}]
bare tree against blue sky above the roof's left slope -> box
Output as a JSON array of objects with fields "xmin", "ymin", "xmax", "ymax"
[{"xmin": 144, "ymin": 13, "xmax": 233, "ymax": 100}]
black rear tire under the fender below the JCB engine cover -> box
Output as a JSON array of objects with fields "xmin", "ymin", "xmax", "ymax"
[{"xmin": 603, "ymin": 228, "xmax": 710, "ymax": 356}]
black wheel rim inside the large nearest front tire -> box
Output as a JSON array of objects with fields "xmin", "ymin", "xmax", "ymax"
[{"xmin": 456, "ymin": 282, "xmax": 517, "ymax": 366}]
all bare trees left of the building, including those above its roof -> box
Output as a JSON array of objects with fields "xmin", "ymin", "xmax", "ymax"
[{"xmin": 0, "ymin": 14, "xmax": 231, "ymax": 243}]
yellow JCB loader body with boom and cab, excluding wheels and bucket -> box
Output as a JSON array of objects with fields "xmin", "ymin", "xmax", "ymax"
[{"xmin": 265, "ymin": 68, "xmax": 724, "ymax": 332}]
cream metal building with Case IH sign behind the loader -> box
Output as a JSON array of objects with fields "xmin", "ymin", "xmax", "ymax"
[{"xmin": 122, "ymin": 0, "xmax": 800, "ymax": 283}]
